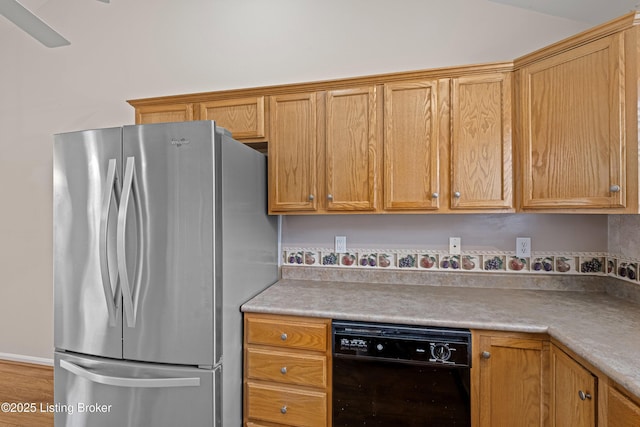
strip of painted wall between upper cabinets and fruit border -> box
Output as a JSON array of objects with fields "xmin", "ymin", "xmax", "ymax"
[{"xmin": 282, "ymin": 214, "xmax": 607, "ymax": 252}]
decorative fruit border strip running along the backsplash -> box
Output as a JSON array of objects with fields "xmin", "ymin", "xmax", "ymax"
[{"xmin": 283, "ymin": 248, "xmax": 640, "ymax": 283}]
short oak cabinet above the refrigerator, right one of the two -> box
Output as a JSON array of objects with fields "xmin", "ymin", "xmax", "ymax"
[{"xmin": 198, "ymin": 96, "xmax": 267, "ymax": 141}]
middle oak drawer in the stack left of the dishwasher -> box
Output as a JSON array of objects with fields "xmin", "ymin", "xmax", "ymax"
[{"xmin": 247, "ymin": 348, "xmax": 327, "ymax": 388}]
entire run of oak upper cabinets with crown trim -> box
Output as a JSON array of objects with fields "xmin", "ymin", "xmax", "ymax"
[{"xmin": 128, "ymin": 12, "xmax": 640, "ymax": 214}]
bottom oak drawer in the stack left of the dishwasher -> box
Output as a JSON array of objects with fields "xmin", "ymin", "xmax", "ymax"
[{"xmin": 247, "ymin": 382, "xmax": 327, "ymax": 427}]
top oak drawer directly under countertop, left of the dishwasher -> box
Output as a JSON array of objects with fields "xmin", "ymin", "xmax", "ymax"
[{"xmin": 246, "ymin": 317, "xmax": 328, "ymax": 352}]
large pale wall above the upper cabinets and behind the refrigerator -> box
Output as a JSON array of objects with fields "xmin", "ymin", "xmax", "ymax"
[{"xmin": 0, "ymin": 0, "xmax": 587, "ymax": 358}]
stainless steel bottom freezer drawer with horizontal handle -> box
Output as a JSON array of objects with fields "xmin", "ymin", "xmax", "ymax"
[{"xmin": 52, "ymin": 352, "xmax": 221, "ymax": 427}]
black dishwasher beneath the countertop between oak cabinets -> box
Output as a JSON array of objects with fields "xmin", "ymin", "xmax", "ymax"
[{"xmin": 332, "ymin": 321, "xmax": 471, "ymax": 427}]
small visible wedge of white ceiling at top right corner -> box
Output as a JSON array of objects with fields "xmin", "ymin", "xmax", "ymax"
[{"xmin": 489, "ymin": 0, "xmax": 640, "ymax": 25}]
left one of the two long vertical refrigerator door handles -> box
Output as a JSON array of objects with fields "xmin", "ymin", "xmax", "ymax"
[{"xmin": 99, "ymin": 159, "xmax": 120, "ymax": 327}]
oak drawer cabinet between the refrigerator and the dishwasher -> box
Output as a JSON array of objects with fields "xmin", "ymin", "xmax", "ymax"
[{"xmin": 244, "ymin": 313, "xmax": 331, "ymax": 427}]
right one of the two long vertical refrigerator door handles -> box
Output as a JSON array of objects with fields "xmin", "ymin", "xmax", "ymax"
[{"xmin": 117, "ymin": 157, "xmax": 144, "ymax": 328}]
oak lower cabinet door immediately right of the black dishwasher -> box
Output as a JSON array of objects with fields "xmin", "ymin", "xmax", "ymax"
[{"xmin": 472, "ymin": 335, "xmax": 548, "ymax": 427}]
